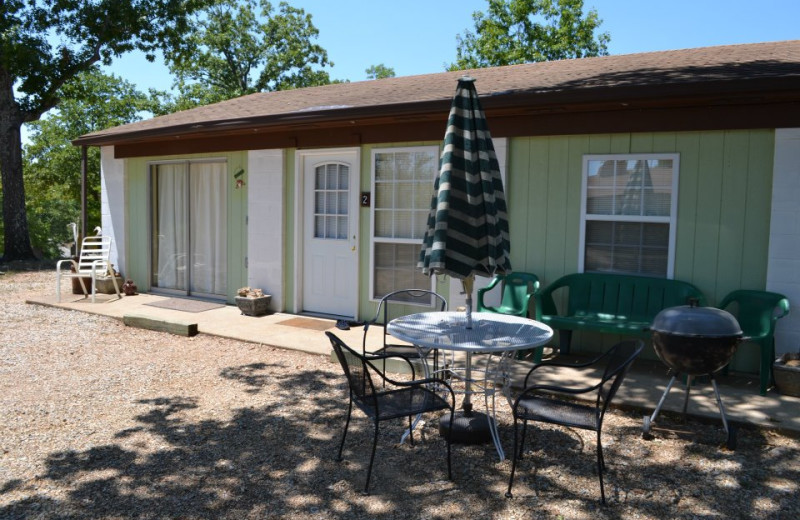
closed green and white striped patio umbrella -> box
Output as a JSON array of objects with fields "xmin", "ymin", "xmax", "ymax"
[{"xmin": 417, "ymin": 77, "xmax": 511, "ymax": 322}]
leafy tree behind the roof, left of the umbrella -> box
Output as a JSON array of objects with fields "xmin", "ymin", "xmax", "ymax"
[{"xmin": 162, "ymin": 0, "xmax": 333, "ymax": 111}]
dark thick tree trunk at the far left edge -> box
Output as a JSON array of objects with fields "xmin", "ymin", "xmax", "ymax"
[{"xmin": 0, "ymin": 74, "xmax": 35, "ymax": 261}]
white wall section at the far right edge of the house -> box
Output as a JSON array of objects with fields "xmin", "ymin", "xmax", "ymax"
[{"xmin": 767, "ymin": 128, "xmax": 800, "ymax": 354}]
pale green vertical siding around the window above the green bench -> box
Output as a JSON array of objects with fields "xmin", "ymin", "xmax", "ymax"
[{"xmin": 508, "ymin": 129, "xmax": 775, "ymax": 371}]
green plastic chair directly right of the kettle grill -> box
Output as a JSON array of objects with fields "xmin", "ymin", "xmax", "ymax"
[{"xmin": 719, "ymin": 289, "xmax": 789, "ymax": 395}]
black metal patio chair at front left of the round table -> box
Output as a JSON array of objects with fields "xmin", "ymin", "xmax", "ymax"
[{"xmin": 325, "ymin": 332, "xmax": 455, "ymax": 494}]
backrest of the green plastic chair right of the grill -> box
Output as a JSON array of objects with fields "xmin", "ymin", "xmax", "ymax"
[{"xmin": 720, "ymin": 289, "xmax": 789, "ymax": 338}]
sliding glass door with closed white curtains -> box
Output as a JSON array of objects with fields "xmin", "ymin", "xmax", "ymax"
[{"xmin": 150, "ymin": 161, "xmax": 228, "ymax": 299}]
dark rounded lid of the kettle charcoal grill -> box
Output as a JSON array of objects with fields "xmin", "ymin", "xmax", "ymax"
[{"xmin": 651, "ymin": 302, "xmax": 742, "ymax": 338}]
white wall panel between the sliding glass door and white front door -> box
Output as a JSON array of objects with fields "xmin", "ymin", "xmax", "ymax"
[{"xmin": 247, "ymin": 150, "xmax": 286, "ymax": 311}]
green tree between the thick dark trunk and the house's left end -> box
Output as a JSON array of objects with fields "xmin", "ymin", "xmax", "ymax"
[{"xmin": 23, "ymin": 66, "xmax": 152, "ymax": 258}]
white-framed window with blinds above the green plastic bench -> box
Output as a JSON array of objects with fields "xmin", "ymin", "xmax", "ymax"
[{"xmin": 579, "ymin": 154, "xmax": 678, "ymax": 278}]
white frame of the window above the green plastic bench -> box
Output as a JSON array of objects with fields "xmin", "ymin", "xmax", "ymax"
[{"xmin": 578, "ymin": 153, "xmax": 680, "ymax": 279}]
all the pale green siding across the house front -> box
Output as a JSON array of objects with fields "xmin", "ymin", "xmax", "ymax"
[{"xmin": 119, "ymin": 130, "xmax": 774, "ymax": 376}]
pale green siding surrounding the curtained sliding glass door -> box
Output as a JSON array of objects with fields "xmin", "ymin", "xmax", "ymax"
[{"xmin": 125, "ymin": 152, "xmax": 247, "ymax": 303}]
